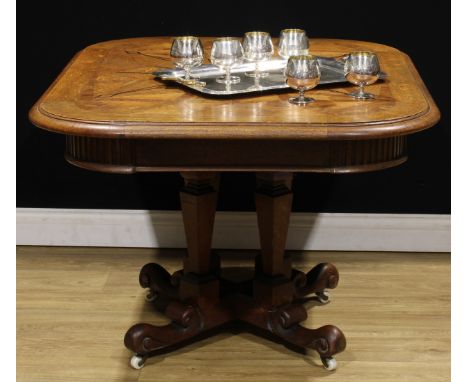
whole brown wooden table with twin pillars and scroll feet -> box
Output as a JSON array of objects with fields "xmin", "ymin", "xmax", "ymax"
[{"xmin": 30, "ymin": 37, "xmax": 439, "ymax": 369}]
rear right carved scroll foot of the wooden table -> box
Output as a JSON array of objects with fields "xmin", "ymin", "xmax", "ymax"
[{"xmin": 291, "ymin": 263, "xmax": 340, "ymax": 303}]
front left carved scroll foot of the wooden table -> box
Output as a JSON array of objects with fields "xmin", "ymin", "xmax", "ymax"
[{"xmin": 124, "ymin": 301, "xmax": 203, "ymax": 363}]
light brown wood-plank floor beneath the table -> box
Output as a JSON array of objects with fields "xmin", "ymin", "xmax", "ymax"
[{"xmin": 17, "ymin": 247, "xmax": 450, "ymax": 382}]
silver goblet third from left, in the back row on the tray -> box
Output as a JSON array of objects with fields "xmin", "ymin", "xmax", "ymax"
[{"xmin": 242, "ymin": 32, "xmax": 274, "ymax": 78}]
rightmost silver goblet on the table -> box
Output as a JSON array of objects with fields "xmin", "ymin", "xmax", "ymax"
[{"xmin": 344, "ymin": 52, "xmax": 380, "ymax": 100}]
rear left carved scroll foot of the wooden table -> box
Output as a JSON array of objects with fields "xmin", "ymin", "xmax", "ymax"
[{"xmin": 139, "ymin": 263, "xmax": 182, "ymax": 301}]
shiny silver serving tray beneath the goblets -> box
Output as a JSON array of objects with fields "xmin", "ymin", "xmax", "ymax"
[{"xmin": 153, "ymin": 57, "xmax": 387, "ymax": 95}]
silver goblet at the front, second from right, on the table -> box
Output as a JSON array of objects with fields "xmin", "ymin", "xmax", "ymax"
[{"xmin": 285, "ymin": 55, "xmax": 320, "ymax": 105}]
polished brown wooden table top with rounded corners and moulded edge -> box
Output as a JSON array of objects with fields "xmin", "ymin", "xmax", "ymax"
[{"xmin": 30, "ymin": 37, "xmax": 439, "ymax": 140}]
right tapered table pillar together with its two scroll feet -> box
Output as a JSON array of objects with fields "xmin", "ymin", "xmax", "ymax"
[{"xmin": 250, "ymin": 173, "xmax": 346, "ymax": 370}]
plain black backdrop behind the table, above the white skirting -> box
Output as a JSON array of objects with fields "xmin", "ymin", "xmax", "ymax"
[{"xmin": 17, "ymin": 0, "xmax": 450, "ymax": 214}]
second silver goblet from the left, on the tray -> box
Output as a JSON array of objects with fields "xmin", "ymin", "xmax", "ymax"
[{"xmin": 211, "ymin": 37, "xmax": 244, "ymax": 85}]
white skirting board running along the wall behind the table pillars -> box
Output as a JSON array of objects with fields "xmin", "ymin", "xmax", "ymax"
[{"xmin": 16, "ymin": 208, "xmax": 450, "ymax": 252}]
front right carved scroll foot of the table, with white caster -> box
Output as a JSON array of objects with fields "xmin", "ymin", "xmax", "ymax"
[{"xmin": 270, "ymin": 304, "xmax": 346, "ymax": 370}]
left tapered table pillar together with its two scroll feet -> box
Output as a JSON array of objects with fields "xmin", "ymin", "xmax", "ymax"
[{"xmin": 124, "ymin": 172, "xmax": 232, "ymax": 368}]
